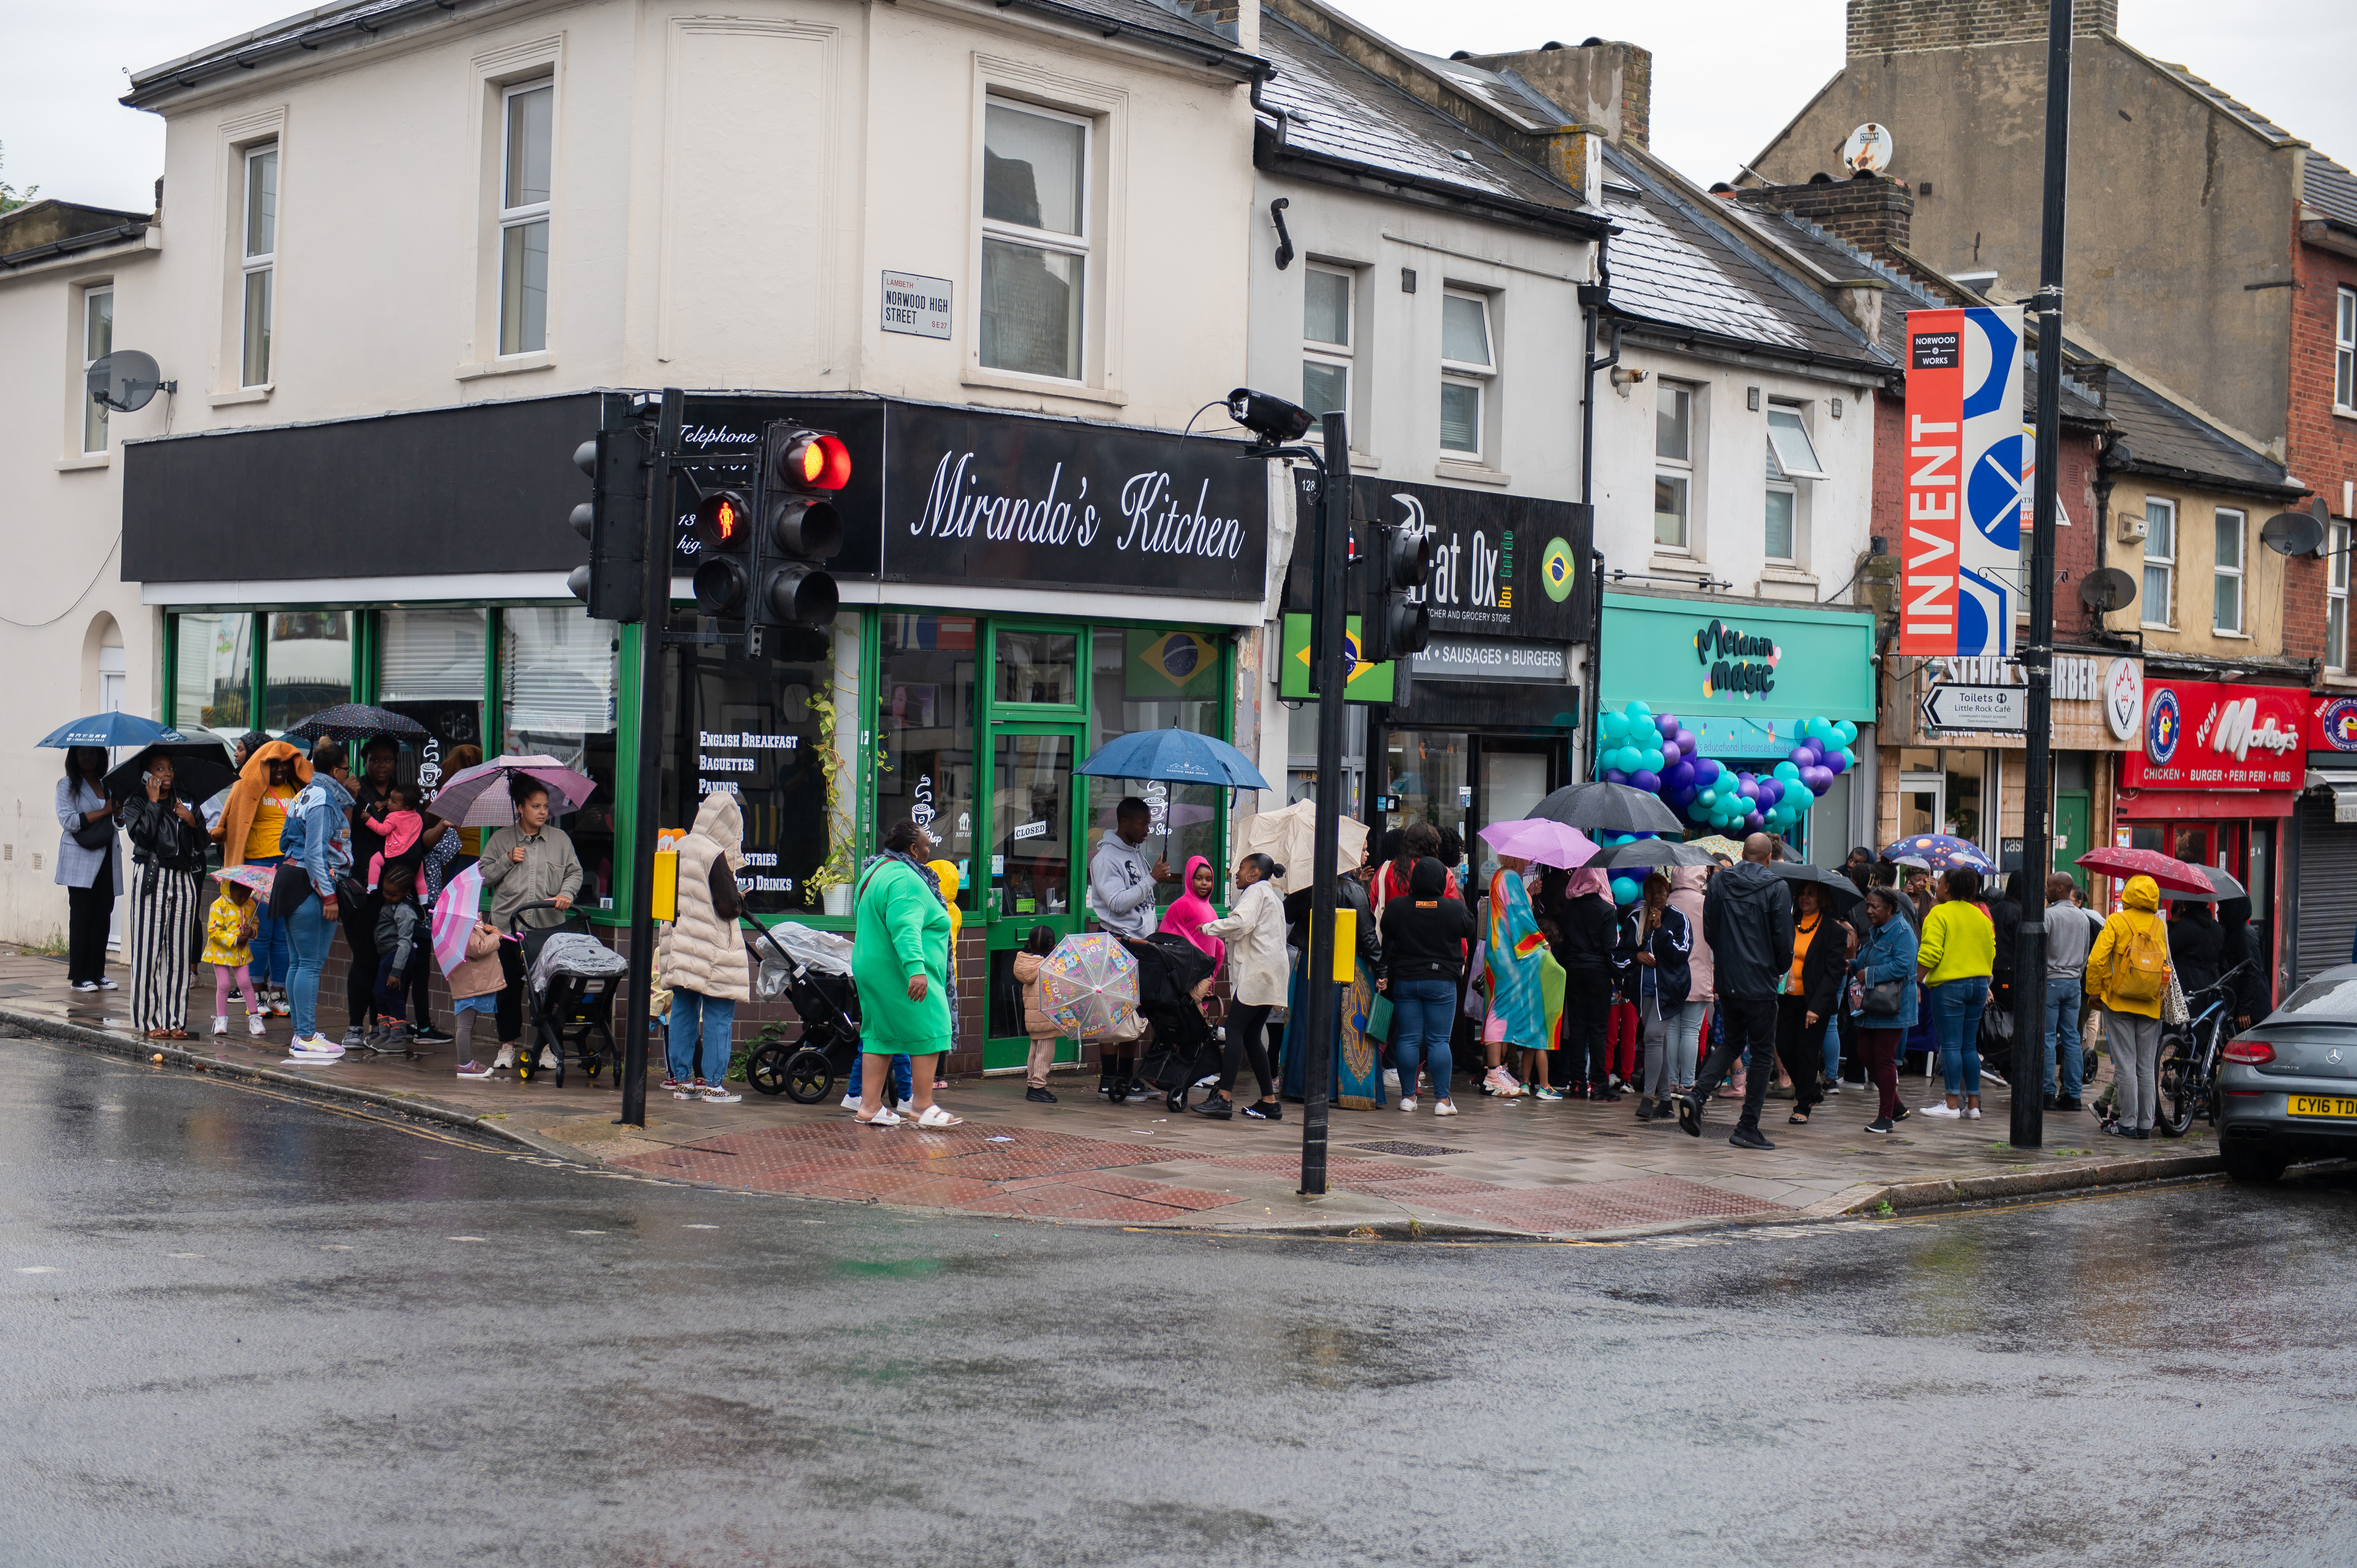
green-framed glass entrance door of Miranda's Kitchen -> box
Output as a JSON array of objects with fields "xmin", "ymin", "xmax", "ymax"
[{"xmin": 976, "ymin": 722, "xmax": 1089, "ymax": 1070}]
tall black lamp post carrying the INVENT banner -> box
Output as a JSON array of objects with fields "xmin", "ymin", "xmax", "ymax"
[{"xmin": 2006, "ymin": 0, "xmax": 2100, "ymax": 1148}]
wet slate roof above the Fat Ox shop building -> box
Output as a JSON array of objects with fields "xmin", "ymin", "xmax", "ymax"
[{"xmin": 1261, "ymin": 12, "xmax": 1586, "ymax": 217}]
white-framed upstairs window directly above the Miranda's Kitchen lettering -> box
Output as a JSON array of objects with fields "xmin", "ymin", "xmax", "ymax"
[{"xmin": 981, "ymin": 99, "xmax": 1089, "ymax": 382}]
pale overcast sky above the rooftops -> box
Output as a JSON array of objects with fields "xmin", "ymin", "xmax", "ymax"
[{"xmin": 0, "ymin": 0, "xmax": 2357, "ymax": 212}]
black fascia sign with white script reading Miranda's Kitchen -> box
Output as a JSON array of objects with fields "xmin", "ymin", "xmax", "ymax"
[{"xmin": 672, "ymin": 399, "xmax": 1268, "ymax": 599}]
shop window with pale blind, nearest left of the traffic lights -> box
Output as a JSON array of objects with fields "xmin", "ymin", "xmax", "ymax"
[{"xmin": 500, "ymin": 606, "xmax": 617, "ymax": 906}]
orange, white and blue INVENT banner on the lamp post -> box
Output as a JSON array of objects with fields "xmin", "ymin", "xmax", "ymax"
[{"xmin": 1898, "ymin": 304, "xmax": 2032, "ymax": 658}]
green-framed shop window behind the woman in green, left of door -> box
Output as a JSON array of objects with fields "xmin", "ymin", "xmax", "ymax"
[{"xmin": 875, "ymin": 615, "xmax": 980, "ymax": 905}]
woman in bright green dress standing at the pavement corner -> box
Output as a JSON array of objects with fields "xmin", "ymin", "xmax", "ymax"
[{"xmin": 851, "ymin": 821, "xmax": 962, "ymax": 1127}]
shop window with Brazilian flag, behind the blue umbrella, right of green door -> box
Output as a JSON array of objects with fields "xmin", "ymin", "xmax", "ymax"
[{"xmin": 1087, "ymin": 627, "xmax": 1228, "ymax": 906}]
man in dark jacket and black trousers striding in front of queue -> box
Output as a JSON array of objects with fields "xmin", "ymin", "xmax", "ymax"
[{"xmin": 1678, "ymin": 832, "xmax": 1791, "ymax": 1148}]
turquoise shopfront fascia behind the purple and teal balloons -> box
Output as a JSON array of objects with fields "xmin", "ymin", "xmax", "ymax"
[{"xmin": 1595, "ymin": 594, "xmax": 1874, "ymax": 865}]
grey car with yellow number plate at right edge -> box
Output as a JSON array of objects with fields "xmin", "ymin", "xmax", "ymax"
[{"xmin": 2216, "ymin": 964, "xmax": 2357, "ymax": 1181}]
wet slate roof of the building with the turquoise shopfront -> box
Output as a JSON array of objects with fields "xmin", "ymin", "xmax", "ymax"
[{"xmin": 1603, "ymin": 146, "xmax": 1898, "ymax": 370}]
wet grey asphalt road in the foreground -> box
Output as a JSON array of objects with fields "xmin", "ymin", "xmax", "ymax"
[{"xmin": 0, "ymin": 1040, "xmax": 2357, "ymax": 1568}]
